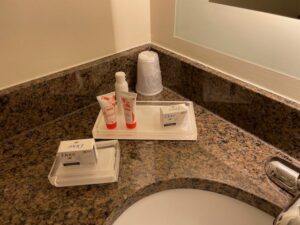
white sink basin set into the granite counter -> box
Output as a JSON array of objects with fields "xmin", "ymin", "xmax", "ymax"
[{"xmin": 114, "ymin": 189, "xmax": 274, "ymax": 225}]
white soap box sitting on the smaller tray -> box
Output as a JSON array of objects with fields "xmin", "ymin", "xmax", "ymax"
[{"xmin": 57, "ymin": 139, "xmax": 97, "ymax": 166}]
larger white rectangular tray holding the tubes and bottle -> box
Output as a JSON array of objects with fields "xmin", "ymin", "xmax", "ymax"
[{"xmin": 93, "ymin": 101, "xmax": 197, "ymax": 140}]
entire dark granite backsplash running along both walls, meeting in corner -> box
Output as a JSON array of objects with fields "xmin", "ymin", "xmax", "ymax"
[{"xmin": 0, "ymin": 45, "xmax": 300, "ymax": 159}]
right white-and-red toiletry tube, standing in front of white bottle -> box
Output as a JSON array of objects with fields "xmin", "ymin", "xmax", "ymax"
[{"xmin": 119, "ymin": 91, "xmax": 137, "ymax": 129}]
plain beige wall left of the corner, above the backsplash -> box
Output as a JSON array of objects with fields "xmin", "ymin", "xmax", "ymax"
[{"xmin": 0, "ymin": 0, "xmax": 150, "ymax": 89}]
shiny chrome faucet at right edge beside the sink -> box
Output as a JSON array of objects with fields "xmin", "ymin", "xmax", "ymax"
[{"xmin": 266, "ymin": 158, "xmax": 300, "ymax": 225}]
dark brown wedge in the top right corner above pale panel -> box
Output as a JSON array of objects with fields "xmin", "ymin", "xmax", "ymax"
[{"xmin": 210, "ymin": 0, "xmax": 300, "ymax": 19}]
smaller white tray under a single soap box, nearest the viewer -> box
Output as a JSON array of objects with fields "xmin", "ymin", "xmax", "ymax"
[{"xmin": 48, "ymin": 140, "xmax": 120, "ymax": 187}]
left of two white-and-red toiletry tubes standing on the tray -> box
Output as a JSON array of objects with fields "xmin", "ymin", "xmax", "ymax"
[{"xmin": 97, "ymin": 92, "xmax": 117, "ymax": 129}]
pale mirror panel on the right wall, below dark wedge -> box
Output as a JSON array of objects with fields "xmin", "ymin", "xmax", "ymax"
[{"xmin": 174, "ymin": 0, "xmax": 300, "ymax": 79}]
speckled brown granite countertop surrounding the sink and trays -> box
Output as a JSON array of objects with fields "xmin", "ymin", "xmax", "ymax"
[{"xmin": 0, "ymin": 89, "xmax": 293, "ymax": 224}]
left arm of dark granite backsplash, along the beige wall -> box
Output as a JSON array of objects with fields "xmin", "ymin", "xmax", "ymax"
[{"xmin": 0, "ymin": 45, "xmax": 150, "ymax": 140}]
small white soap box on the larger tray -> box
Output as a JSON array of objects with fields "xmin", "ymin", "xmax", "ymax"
[{"xmin": 160, "ymin": 104, "xmax": 188, "ymax": 127}]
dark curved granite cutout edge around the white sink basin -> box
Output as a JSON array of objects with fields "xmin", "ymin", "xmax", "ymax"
[{"xmin": 104, "ymin": 178, "xmax": 282, "ymax": 225}]
